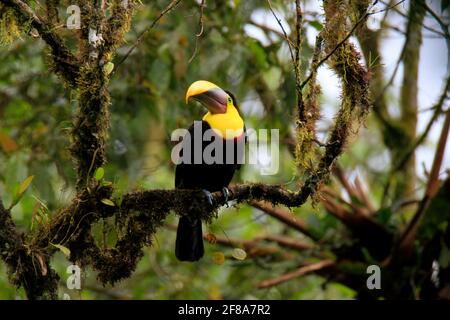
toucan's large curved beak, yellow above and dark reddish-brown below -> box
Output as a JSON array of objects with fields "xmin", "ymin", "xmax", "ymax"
[{"xmin": 186, "ymin": 80, "xmax": 228, "ymax": 113}]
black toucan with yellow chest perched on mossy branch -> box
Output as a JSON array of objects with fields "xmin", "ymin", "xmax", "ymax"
[{"xmin": 175, "ymin": 80, "xmax": 245, "ymax": 261}]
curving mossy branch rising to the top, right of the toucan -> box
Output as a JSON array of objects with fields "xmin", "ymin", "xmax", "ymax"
[{"xmin": 297, "ymin": 1, "xmax": 371, "ymax": 202}]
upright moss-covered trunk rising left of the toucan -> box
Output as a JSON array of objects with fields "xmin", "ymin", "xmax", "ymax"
[{"xmin": 70, "ymin": 1, "xmax": 135, "ymax": 191}]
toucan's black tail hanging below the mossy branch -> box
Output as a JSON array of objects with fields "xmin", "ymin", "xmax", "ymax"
[{"xmin": 175, "ymin": 216, "xmax": 205, "ymax": 261}]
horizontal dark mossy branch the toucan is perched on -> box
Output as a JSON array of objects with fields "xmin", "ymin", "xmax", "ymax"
[{"xmin": 20, "ymin": 184, "xmax": 316, "ymax": 290}]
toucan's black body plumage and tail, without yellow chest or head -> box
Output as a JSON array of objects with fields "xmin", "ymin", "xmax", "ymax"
[{"xmin": 175, "ymin": 121, "xmax": 245, "ymax": 261}]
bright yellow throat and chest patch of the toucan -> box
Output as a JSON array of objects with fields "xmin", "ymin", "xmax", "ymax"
[{"xmin": 203, "ymin": 104, "xmax": 244, "ymax": 139}]
